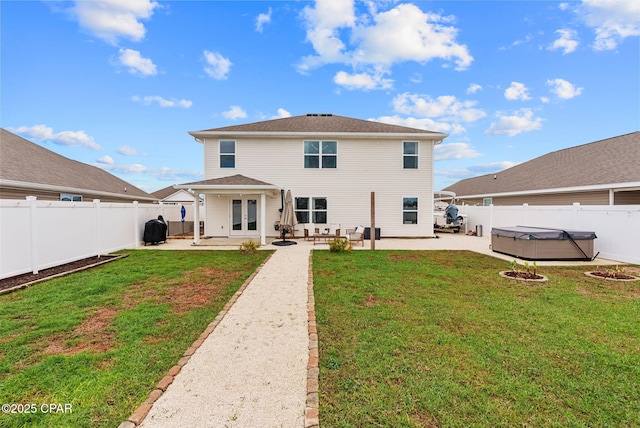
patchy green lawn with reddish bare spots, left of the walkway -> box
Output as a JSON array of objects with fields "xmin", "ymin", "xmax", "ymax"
[{"xmin": 0, "ymin": 250, "xmax": 270, "ymax": 428}]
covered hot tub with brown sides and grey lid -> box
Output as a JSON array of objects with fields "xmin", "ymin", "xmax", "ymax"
[{"xmin": 491, "ymin": 226, "xmax": 596, "ymax": 260}]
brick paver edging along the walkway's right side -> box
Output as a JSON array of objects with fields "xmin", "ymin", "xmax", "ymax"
[{"xmin": 304, "ymin": 249, "xmax": 320, "ymax": 428}]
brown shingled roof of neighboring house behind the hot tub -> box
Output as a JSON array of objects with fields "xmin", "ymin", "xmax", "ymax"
[{"xmin": 443, "ymin": 132, "xmax": 640, "ymax": 197}]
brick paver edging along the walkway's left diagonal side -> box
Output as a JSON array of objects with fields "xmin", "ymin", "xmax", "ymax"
[{"xmin": 118, "ymin": 253, "xmax": 276, "ymax": 428}]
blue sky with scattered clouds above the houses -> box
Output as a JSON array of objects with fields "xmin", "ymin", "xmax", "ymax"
[{"xmin": 0, "ymin": 0, "xmax": 640, "ymax": 192}]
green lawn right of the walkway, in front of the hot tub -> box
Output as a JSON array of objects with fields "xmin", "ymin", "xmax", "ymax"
[{"xmin": 313, "ymin": 251, "xmax": 640, "ymax": 427}]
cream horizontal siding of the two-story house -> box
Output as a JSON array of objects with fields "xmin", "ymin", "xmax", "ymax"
[{"xmin": 204, "ymin": 136, "xmax": 433, "ymax": 237}]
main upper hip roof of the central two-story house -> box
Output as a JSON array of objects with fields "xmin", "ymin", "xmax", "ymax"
[{"xmin": 190, "ymin": 114, "xmax": 447, "ymax": 139}]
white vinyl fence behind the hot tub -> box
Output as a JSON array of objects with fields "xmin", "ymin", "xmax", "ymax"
[{"xmin": 458, "ymin": 203, "xmax": 640, "ymax": 264}]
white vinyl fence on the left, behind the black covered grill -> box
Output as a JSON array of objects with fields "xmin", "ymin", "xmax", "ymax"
[{"xmin": 0, "ymin": 196, "xmax": 162, "ymax": 279}]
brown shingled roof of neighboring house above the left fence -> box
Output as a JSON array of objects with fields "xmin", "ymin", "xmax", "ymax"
[{"xmin": 0, "ymin": 128, "xmax": 156, "ymax": 201}]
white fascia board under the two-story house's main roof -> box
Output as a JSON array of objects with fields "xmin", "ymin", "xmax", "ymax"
[{"xmin": 189, "ymin": 131, "xmax": 449, "ymax": 145}]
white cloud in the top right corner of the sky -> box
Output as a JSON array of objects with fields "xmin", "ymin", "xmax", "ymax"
[{"xmin": 578, "ymin": 0, "xmax": 640, "ymax": 51}]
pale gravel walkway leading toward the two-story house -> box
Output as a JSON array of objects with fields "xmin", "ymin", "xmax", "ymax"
[{"xmin": 140, "ymin": 245, "xmax": 310, "ymax": 428}]
